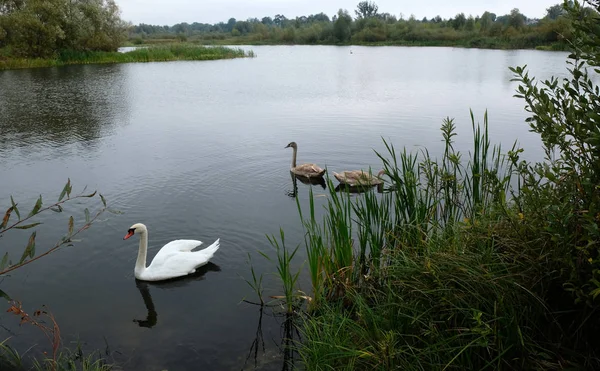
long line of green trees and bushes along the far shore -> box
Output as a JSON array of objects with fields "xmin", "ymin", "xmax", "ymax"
[{"xmin": 129, "ymin": 1, "xmax": 593, "ymax": 48}]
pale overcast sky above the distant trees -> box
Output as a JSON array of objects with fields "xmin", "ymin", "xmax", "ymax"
[{"xmin": 115, "ymin": 0, "xmax": 562, "ymax": 26}]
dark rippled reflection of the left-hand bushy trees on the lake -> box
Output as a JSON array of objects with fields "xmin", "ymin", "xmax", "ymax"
[{"xmin": 0, "ymin": 64, "xmax": 130, "ymax": 151}]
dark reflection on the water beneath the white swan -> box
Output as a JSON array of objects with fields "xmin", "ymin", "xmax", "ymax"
[{"xmin": 133, "ymin": 262, "xmax": 221, "ymax": 328}]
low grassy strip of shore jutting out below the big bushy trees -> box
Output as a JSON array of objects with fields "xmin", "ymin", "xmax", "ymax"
[{"xmin": 0, "ymin": 43, "xmax": 254, "ymax": 70}]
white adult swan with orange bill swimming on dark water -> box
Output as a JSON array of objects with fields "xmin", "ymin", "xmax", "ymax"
[{"xmin": 123, "ymin": 223, "xmax": 220, "ymax": 281}]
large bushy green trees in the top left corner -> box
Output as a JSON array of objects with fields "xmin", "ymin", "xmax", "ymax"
[{"xmin": 0, "ymin": 0, "xmax": 131, "ymax": 60}]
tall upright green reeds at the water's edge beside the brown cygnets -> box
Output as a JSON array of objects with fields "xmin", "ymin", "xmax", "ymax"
[{"xmin": 297, "ymin": 109, "xmax": 514, "ymax": 303}]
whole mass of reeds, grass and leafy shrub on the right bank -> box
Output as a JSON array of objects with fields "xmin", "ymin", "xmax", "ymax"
[{"xmin": 251, "ymin": 0, "xmax": 600, "ymax": 370}]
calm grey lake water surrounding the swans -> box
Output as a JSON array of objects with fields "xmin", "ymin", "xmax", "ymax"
[{"xmin": 0, "ymin": 46, "xmax": 566, "ymax": 370}]
